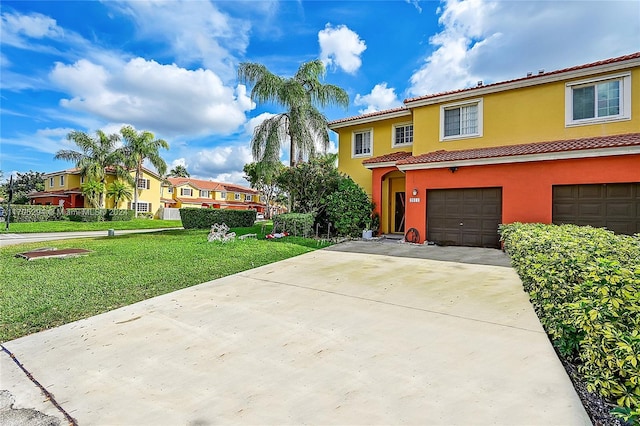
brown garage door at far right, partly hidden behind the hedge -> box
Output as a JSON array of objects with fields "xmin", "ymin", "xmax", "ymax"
[{"xmin": 553, "ymin": 182, "xmax": 640, "ymax": 234}]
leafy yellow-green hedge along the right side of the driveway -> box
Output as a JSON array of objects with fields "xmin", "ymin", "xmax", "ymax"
[{"xmin": 501, "ymin": 223, "xmax": 640, "ymax": 424}]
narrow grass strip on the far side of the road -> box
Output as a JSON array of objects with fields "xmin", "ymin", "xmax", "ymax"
[{"xmin": 0, "ymin": 219, "xmax": 182, "ymax": 234}]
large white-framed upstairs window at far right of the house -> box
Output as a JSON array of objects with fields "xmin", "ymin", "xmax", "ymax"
[{"xmin": 565, "ymin": 73, "xmax": 631, "ymax": 126}]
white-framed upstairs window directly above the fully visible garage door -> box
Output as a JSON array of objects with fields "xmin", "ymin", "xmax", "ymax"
[{"xmin": 440, "ymin": 99, "xmax": 482, "ymax": 140}]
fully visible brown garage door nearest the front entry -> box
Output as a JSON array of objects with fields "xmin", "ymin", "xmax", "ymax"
[{"xmin": 427, "ymin": 188, "xmax": 502, "ymax": 247}]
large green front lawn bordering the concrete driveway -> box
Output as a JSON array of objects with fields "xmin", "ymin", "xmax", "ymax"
[{"xmin": 0, "ymin": 225, "xmax": 327, "ymax": 341}]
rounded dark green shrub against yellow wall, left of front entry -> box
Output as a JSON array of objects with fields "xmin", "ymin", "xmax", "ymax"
[{"xmin": 327, "ymin": 177, "xmax": 373, "ymax": 237}]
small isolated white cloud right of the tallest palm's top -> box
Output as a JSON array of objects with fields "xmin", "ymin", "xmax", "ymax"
[{"xmin": 318, "ymin": 24, "xmax": 367, "ymax": 74}]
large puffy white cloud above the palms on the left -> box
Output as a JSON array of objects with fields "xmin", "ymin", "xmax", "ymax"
[{"xmin": 50, "ymin": 58, "xmax": 254, "ymax": 136}]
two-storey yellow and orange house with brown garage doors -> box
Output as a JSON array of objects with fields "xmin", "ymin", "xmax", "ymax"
[{"xmin": 329, "ymin": 52, "xmax": 640, "ymax": 247}]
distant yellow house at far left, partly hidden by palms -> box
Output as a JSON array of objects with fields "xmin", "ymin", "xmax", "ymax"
[{"xmin": 27, "ymin": 168, "xmax": 162, "ymax": 213}]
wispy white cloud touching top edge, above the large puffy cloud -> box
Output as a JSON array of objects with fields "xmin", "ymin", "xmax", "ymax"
[{"xmin": 104, "ymin": 0, "xmax": 253, "ymax": 81}]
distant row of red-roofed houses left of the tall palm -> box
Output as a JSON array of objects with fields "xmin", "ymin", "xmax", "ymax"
[{"xmin": 162, "ymin": 177, "xmax": 265, "ymax": 213}]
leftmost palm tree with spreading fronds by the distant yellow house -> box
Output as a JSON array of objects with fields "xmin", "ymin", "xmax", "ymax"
[{"xmin": 54, "ymin": 130, "xmax": 132, "ymax": 207}]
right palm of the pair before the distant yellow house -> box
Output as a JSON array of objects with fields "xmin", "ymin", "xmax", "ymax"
[{"xmin": 120, "ymin": 126, "xmax": 169, "ymax": 217}]
